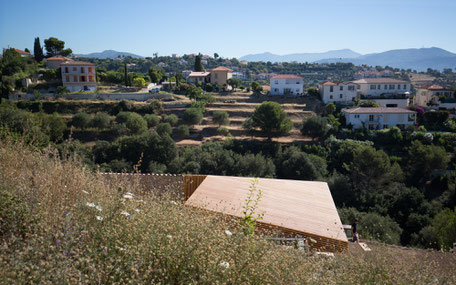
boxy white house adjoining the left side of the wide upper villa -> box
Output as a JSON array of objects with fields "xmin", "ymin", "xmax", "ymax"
[{"xmin": 318, "ymin": 81, "xmax": 357, "ymax": 104}]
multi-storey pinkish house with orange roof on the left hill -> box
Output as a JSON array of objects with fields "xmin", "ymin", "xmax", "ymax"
[{"xmin": 60, "ymin": 61, "xmax": 97, "ymax": 92}]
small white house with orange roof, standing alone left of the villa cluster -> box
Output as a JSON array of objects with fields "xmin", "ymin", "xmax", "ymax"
[{"xmin": 270, "ymin": 74, "xmax": 304, "ymax": 95}]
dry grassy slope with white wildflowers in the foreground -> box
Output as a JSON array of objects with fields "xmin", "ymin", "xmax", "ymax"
[{"xmin": 0, "ymin": 141, "xmax": 456, "ymax": 284}]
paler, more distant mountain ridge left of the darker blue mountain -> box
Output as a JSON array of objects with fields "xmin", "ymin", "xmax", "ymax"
[{"xmin": 239, "ymin": 49, "xmax": 361, "ymax": 62}]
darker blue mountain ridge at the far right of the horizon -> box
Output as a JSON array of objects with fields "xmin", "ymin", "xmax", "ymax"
[{"xmin": 317, "ymin": 47, "xmax": 456, "ymax": 71}]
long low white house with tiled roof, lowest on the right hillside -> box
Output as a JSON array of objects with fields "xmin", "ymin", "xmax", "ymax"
[{"xmin": 342, "ymin": 107, "xmax": 416, "ymax": 130}]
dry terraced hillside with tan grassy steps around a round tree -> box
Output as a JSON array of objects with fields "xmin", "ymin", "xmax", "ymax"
[{"xmin": 164, "ymin": 93, "xmax": 322, "ymax": 145}]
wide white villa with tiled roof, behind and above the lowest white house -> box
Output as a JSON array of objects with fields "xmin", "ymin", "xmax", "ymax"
[{"xmin": 353, "ymin": 78, "xmax": 410, "ymax": 97}]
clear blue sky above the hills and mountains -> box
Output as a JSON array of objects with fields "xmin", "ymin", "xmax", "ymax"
[{"xmin": 0, "ymin": 0, "xmax": 456, "ymax": 58}]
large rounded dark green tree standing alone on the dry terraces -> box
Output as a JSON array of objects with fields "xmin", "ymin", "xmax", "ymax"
[{"xmin": 252, "ymin": 101, "xmax": 292, "ymax": 139}]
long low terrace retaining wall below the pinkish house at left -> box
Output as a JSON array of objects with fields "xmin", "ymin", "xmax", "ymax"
[{"xmin": 9, "ymin": 93, "xmax": 173, "ymax": 101}]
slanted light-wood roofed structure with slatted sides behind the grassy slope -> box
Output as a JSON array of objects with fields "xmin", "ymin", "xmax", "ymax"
[{"xmin": 184, "ymin": 175, "xmax": 348, "ymax": 252}]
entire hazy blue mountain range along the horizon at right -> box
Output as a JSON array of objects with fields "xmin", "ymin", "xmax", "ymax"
[{"xmin": 239, "ymin": 47, "xmax": 456, "ymax": 71}]
